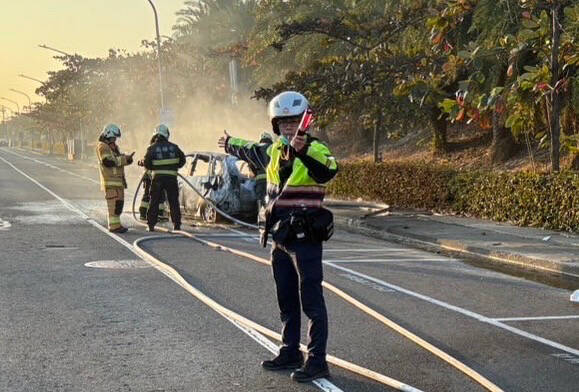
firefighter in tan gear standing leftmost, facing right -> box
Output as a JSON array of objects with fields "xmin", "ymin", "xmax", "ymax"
[{"xmin": 96, "ymin": 124, "xmax": 135, "ymax": 233}]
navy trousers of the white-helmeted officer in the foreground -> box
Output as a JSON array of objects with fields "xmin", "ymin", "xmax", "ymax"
[{"xmin": 271, "ymin": 241, "xmax": 328, "ymax": 364}]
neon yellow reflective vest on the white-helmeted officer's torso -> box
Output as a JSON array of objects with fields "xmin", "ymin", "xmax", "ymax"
[{"xmin": 266, "ymin": 140, "xmax": 338, "ymax": 207}]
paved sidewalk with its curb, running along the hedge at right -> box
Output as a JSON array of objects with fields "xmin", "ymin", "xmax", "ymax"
[{"xmin": 327, "ymin": 200, "xmax": 579, "ymax": 280}]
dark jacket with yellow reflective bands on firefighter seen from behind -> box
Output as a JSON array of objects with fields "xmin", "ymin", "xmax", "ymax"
[{"xmin": 144, "ymin": 137, "xmax": 186, "ymax": 177}]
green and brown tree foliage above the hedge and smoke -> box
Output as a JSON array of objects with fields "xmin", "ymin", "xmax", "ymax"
[{"xmin": 18, "ymin": 0, "xmax": 579, "ymax": 170}]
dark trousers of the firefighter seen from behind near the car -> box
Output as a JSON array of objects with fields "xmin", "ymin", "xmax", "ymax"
[{"xmin": 147, "ymin": 174, "xmax": 181, "ymax": 226}]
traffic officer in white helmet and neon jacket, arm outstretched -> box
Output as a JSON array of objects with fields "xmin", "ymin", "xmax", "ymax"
[{"xmin": 218, "ymin": 91, "xmax": 338, "ymax": 382}]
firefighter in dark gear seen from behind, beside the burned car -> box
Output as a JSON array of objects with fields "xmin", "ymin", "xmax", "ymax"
[{"xmin": 144, "ymin": 124, "xmax": 185, "ymax": 231}]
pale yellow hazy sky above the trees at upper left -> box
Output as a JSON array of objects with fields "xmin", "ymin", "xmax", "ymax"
[{"xmin": 0, "ymin": 0, "xmax": 184, "ymax": 109}]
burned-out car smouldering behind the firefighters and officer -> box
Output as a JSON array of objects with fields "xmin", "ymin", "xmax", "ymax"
[{"xmin": 179, "ymin": 152, "xmax": 258, "ymax": 223}]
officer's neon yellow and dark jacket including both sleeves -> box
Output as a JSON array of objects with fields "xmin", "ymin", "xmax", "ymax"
[{"xmin": 225, "ymin": 135, "xmax": 338, "ymax": 209}]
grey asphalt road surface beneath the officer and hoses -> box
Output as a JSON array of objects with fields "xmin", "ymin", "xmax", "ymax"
[{"xmin": 0, "ymin": 148, "xmax": 579, "ymax": 391}]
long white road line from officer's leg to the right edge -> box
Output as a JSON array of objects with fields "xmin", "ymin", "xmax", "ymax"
[{"xmin": 324, "ymin": 262, "xmax": 579, "ymax": 356}]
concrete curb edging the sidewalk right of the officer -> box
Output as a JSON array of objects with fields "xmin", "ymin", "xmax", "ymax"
[{"xmin": 334, "ymin": 215, "xmax": 579, "ymax": 279}]
